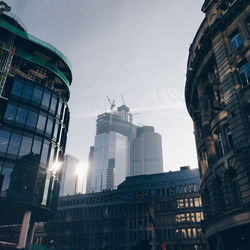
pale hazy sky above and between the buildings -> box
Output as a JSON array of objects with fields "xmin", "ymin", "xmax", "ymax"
[{"xmin": 6, "ymin": 0, "xmax": 204, "ymax": 171}]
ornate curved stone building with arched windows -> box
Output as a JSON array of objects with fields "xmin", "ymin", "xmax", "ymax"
[{"xmin": 185, "ymin": 0, "xmax": 250, "ymax": 250}]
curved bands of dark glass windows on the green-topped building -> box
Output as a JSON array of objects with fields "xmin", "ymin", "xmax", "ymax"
[{"xmin": 0, "ymin": 77, "xmax": 69, "ymax": 219}]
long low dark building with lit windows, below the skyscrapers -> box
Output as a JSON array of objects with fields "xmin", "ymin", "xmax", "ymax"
[{"xmin": 37, "ymin": 167, "xmax": 203, "ymax": 250}]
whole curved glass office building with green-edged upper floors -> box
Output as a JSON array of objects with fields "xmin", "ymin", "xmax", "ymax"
[{"xmin": 0, "ymin": 15, "xmax": 72, "ymax": 224}]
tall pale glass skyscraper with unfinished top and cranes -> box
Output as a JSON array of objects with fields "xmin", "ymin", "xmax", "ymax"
[{"xmin": 87, "ymin": 105, "xmax": 137, "ymax": 192}]
